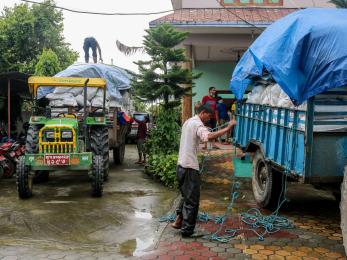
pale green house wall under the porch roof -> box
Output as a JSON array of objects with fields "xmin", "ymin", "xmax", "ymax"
[{"xmin": 193, "ymin": 62, "xmax": 236, "ymax": 107}]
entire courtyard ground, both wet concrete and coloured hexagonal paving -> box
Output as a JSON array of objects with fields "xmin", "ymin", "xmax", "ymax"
[{"xmin": 0, "ymin": 146, "xmax": 345, "ymax": 260}]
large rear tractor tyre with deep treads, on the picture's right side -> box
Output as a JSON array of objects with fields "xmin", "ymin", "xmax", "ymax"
[{"xmin": 90, "ymin": 126, "xmax": 110, "ymax": 181}]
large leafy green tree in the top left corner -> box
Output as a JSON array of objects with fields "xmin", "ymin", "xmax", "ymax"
[{"xmin": 0, "ymin": 0, "xmax": 78, "ymax": 73}]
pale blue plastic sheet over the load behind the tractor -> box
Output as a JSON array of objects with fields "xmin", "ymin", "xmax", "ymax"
[{"xmin": 38, "ymin": 63, "xmax": 131, "ymax": 101}]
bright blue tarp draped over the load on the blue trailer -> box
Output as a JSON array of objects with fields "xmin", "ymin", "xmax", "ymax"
[{"xmin": 230, "ymin": 8, "xmax": 347, "ymax": 105}]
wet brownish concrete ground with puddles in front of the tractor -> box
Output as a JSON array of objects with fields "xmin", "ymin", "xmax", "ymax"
[{"xmin": 0, "ymin": 146, "xmax": 177, "ymax": 260}]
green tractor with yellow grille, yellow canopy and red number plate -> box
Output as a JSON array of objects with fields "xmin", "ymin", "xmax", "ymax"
[{"xmin": 17, "ymin": 77, "xmax": 109, "ymax": 199}]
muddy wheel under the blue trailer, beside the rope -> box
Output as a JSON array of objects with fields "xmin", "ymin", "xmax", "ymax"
[{"xmin": 252, "ymin": 150, "xmax": 283, "ymax": 209}]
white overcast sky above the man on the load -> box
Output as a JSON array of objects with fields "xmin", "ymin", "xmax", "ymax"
[{"xmin": 0, "ymin": 0, "xmax": 172, "ymax": 70}]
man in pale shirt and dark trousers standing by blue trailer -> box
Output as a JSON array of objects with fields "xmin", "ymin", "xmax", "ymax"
[{"xmin": 172, "ymin": 105, "xmax": 236, "ymax": 237}]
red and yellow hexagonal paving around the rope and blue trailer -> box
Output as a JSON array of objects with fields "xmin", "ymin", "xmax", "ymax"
[{"xmin": 148, "ymin": 147, "xmax": 346, "ymax": 260}]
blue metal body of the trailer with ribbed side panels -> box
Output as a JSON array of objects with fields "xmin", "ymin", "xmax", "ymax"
[{"xmin": 234, "ymin": 88, "xmax": 347, "ymax": 207}]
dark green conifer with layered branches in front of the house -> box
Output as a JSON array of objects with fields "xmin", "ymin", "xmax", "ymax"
[{"xmin": 132, "ymin": 24, "xmax": 200, "ymax": 108}]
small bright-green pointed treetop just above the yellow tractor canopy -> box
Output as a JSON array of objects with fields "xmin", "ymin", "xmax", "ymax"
[{"xmin": 35, "ymin": 49, "xmax": 61, "ymax": 76}]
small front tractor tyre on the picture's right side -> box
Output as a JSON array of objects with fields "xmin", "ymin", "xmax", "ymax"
[{"xmin": 92, "ymin": 155, "xmax": 104, "ymax": 197}]
